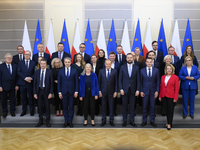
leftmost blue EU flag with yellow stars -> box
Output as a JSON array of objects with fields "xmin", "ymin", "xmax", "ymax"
[{"xmin": 33, "ymin": 20, "xmax": 42, "ymax": 55}]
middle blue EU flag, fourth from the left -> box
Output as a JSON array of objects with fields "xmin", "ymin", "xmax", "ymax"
[{"xmin": 107, "ymin": 20, "xmax": 117, "ymax": 55}]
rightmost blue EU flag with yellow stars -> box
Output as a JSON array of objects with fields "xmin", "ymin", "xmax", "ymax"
[{"xmin": 182, "ymin": 19, "xmax": 194, "ymax": 54}]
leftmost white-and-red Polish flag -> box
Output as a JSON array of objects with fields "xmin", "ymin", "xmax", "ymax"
[{"xmin": 22, "ymin": 20, "xmax": 32, "ymax": 58}]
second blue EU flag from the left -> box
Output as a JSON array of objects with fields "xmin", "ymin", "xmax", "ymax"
[{"xmin": 60, "ymin": 20, "xmax": 70, "ymax": 55}]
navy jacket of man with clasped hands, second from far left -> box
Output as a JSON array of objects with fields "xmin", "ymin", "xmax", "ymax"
[{"xmin": 17, "ymin": 60, "xmax": 35, "ymax": 85}]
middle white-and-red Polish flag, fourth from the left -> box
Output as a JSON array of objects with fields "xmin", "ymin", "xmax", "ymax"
[{"xmin": 95, "ymin": 20, "xmax": 108, "ymax": 58}]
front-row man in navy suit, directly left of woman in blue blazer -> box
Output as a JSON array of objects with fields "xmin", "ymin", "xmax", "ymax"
[{"xmin": 58, "ymin": 57, "xmax": 78, "ymax": 128}]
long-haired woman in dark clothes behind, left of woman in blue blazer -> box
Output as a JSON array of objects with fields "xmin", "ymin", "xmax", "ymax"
[{"xmin": 72, "ymin": 54, "xmax": 85, "ymax": 116}]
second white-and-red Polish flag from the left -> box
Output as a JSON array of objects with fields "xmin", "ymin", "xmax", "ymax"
[{"xmin": 46, "ymin": 20, "xmax": 56, "ymax": 57}]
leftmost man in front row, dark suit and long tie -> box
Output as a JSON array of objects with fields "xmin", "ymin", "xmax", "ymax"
[{"xmin": 33, "ymin": 58, "xmax": 53, "ymax": 127}]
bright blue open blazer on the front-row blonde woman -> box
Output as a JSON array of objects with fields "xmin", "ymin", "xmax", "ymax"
[{"xmin": 79, "ymin": 72, "xmax": 99, "ymax": 97}]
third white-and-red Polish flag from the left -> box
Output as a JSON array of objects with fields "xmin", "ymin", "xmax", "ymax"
[{"xmin": 71, "ymin": 20, "xmax": 81, "ymax": 62}]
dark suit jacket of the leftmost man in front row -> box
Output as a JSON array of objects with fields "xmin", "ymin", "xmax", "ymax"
[{"xmin": 33, "ymin": 69, "xmax": 53, "ymax": 96}]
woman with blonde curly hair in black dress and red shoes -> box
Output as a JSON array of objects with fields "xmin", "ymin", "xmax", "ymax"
[{"xmin": 51, "ymin": 58, "xmax": 63, "ymax": 116}]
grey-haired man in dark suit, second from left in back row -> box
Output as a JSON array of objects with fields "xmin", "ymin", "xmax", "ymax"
[{"xmin": 33, "ymin": 43, "xmax": 51, "ymax": 66}]
